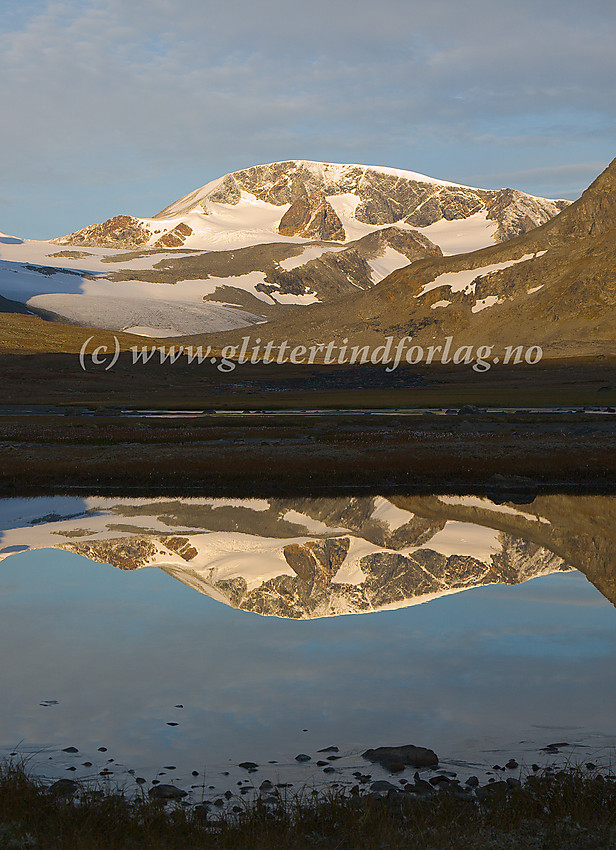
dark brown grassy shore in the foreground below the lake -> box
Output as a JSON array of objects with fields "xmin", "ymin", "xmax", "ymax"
[{"xmin": 0, "ymin": 764, "xmax": 616, "ymax": 850}]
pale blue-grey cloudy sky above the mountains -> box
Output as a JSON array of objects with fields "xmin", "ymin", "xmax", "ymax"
[{"xmin": 0, "ymin": 0, "xmax": 616, "ymax": 239}]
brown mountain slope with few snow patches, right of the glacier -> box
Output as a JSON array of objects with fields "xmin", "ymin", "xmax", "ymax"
[{"xmin": 218, "ymin": 160, "xmax": 616, "ymax": 356}]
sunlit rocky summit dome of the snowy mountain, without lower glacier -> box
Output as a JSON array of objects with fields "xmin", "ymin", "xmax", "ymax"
[{"xmin": 54, "ymin": 160, "xmax": 569, "ymax": 253}]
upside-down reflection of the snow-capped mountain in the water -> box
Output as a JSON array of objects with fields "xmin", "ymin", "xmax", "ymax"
[{"xmin": 0, "ymin": 490, "xmax": 569, "ymax": 619}]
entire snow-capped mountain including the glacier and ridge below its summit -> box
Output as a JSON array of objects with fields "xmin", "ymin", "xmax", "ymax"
[{"xmin": 0, "ymin": 160, "xmax": 569, "ymax": 337}]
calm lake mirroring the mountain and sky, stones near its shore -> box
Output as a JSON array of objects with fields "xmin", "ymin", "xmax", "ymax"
[{"xmin": 0, "ymin": 495, "xmax": 616, "ymax": 799}]
